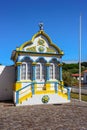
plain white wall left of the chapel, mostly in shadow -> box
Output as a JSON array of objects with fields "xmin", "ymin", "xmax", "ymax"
[{"xmin": 0, "ymin": 65, "xmax": 15, "ymax": 101}]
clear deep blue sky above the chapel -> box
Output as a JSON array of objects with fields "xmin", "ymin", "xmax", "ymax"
[{"xmin": 0, "ymin": 0, "xmax": 87, "ymax": 65}]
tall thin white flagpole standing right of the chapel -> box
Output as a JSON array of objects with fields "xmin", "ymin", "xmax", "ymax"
[{"xmin": 79, "ymin": 15, "xmax": 81, "ymax": 101}]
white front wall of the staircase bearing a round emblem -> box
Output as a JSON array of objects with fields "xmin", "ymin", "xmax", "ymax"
[{"xmin": 16, "ymin": 94, "xmax": 70, "ymax": 106}]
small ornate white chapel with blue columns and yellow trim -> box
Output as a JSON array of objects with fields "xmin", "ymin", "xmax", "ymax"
[{"xmin": 11, "ymin": 24, "xmax": 70, "ymax": 106}]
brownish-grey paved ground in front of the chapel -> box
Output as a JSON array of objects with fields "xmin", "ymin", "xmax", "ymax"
[{"xmin": 0, "ymin": 100, "xmax": 87, "ymax": 130}]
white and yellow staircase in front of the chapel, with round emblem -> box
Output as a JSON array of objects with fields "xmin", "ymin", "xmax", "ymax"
[{"xmin": 16, "ymin": 83, "xmax": 70, "ymax": 106}]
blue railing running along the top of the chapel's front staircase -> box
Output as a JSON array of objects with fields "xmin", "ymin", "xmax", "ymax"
[{"xmin": 16, "ymin": 81, "xmax": 70, "ymax": 104}]
